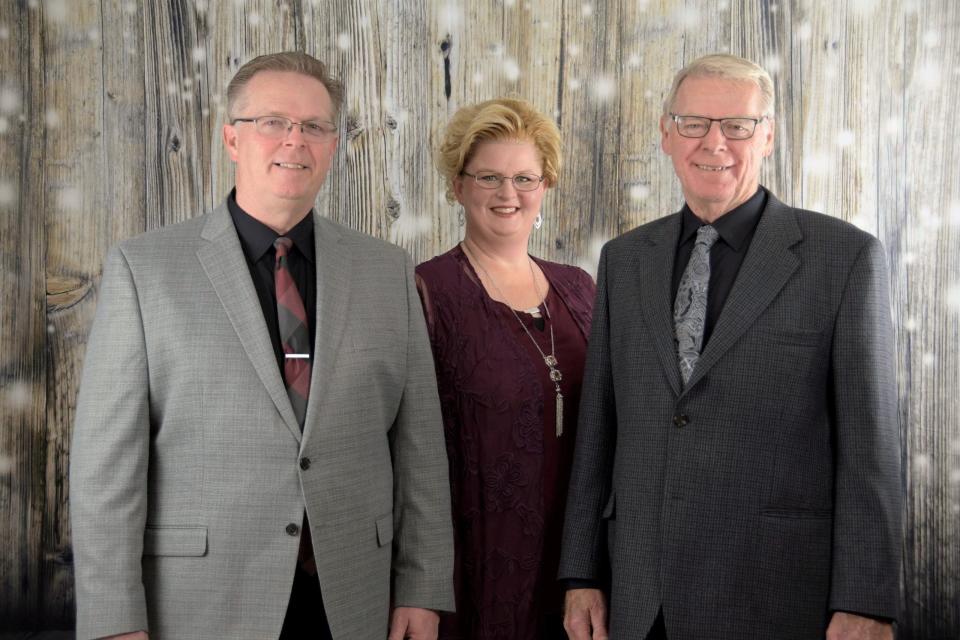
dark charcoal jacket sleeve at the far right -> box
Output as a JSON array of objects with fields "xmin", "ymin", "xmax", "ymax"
[{"xmin": 830, "ymin": 238, "xmax": 903, "ymax": 618}]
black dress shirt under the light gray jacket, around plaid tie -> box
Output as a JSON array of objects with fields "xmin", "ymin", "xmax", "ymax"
[{"xmin": 227, "ymin": 190, "xmax": 317, "ymax": 377}]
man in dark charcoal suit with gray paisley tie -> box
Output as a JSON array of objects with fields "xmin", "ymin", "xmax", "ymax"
[{"xmin": 560, "ymin": 55, "xmax": 902, "ymax": 640}]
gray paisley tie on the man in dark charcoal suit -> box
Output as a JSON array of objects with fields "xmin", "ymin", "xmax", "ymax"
[{"xmin": 673, "ymin": 225, "xmax": 718, "ymax": 385}]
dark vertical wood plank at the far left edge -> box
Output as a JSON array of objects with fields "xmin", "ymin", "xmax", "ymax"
[{"xmin": 0, "ymin": 3, "xmax": 46, "ymax": 629}]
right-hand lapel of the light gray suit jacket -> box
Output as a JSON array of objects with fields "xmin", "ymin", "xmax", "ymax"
[{"xmin": 303, "ymin": 218, "xmax": 353, "ymax": 438}]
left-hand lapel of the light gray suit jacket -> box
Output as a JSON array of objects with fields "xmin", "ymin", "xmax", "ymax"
[{"xmin": 197, "ymin": 202, "xmax": 300, "ymax": 442}]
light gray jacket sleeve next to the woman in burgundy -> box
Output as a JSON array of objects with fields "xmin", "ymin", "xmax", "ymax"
[{"xmin": 390, "ymin": 250, "xmax": 454, "ymax": 611}]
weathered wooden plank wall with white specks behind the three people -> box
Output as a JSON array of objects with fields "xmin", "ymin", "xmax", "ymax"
[{"xmin": 0, "ymin": 0, "xmax": 960, "ymax": 639}]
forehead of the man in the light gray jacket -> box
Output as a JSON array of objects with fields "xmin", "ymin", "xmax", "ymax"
[{"xmin": 239, "ymin": 71, "xmax": 333, "ymax": 119}]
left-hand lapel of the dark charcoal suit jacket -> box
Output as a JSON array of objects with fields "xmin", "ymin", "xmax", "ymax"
[{"xmin": 632, "ymin": 213, "xmax": 682, "ymax": 396}]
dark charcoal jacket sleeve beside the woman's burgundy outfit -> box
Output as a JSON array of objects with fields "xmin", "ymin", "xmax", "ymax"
[{"xmin": 558, "ymin": 246, "xmax": 617, "ymax": 584}]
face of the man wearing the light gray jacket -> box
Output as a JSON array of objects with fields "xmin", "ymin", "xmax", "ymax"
[{"xmin": 223, "ymin": 71, "xmax": 337, "ymax": 215}]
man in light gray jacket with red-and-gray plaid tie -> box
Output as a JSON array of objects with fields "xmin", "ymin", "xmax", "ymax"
[{"xmin": 70, "ymin": 53, "xmax": 453, "ymax": 640}]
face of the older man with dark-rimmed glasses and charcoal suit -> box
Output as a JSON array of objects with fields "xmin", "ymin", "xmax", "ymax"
[{"xmin": 660, "ymin": 76, "xmax": 773, "ymax": 221}]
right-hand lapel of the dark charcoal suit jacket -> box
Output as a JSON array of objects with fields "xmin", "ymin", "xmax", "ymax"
[{"xmin": 687, "ymin": 193, "xmax": 803, "ymax": 389}]
